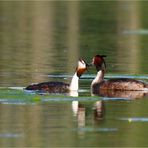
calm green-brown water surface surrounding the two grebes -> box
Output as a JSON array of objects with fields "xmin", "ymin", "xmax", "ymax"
[{"xmin": 0, "ymin": 1, "xmax": 148, "ymax": 147}]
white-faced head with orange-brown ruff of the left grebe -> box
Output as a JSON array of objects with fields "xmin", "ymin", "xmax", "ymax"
[{"xmin": 76, "ymin": 59, "xmax": 87, "ymax": 77}]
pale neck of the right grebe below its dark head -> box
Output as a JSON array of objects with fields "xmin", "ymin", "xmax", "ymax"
[{"xmin": 91, "ymin": 70, "xmax": 104, "ymax": 86}]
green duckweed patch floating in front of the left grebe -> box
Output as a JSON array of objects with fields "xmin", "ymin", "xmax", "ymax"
[{"xmin": 0, "ymin": 88, "xmax": 102, "ymax": 103}]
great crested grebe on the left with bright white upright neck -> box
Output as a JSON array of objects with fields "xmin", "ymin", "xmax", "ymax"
[{"xmin": 25, "ymin": 59, "xmax": 87, "ymax": 93}]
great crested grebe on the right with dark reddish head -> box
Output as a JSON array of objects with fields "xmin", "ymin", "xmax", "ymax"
[{"xmin": 91, "ymin": 55, "xmax": 148, "ymax": 94}]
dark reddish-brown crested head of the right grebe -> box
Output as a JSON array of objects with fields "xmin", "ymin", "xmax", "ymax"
[{"xmin": 92, "ymin": 55, "xmax": 106, "ymax": 71}]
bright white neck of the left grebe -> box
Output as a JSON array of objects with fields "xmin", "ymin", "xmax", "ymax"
[{"xmin": 69, "ymin": 72, "xmax": 79, "ymax": 91}]
